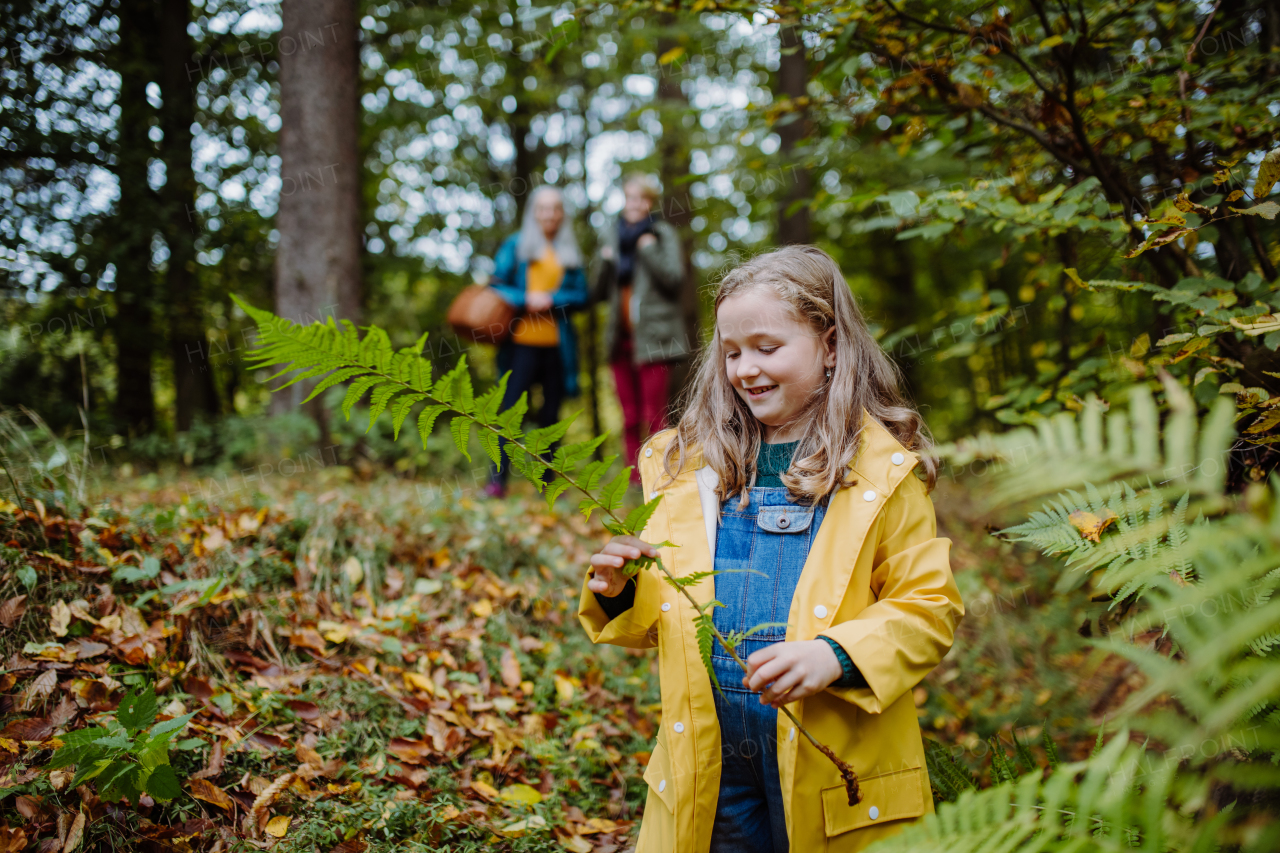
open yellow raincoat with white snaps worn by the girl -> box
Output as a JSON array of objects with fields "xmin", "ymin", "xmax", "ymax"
[{"xmin": 579, "ymin": 418, "xmax": 964, "ymax": 853}]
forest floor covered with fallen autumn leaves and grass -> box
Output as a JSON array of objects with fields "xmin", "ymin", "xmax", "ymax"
[{"xmin": 0, "ymin": 466, "xmax": 1135, "ymax": 853}]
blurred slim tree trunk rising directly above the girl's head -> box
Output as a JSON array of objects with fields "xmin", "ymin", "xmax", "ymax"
[{"xmin": 777, "ymin": 26, "xmax": 813, "ymax": 246}]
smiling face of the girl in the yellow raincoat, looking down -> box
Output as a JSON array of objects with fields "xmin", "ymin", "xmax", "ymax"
[{"xmin": 716, "ymin": 287, "xmax": 836, "ymax": 444}]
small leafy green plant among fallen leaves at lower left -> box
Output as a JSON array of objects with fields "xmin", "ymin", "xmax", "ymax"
[{"xmin": 47, "ymin": 684, "xmax": 196, "ymax": 804}]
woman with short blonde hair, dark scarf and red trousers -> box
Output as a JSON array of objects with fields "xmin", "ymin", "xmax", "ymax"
[{"xmin": 591, "ymin": 175, "xmax": 690, "ymax": 483}]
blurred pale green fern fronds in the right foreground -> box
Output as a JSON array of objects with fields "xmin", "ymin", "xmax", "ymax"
[{"xmin": 870, "ymin": 379, "xmax": 1280, "ymax": 853}]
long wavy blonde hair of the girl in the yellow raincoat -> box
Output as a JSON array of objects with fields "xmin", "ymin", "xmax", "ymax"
[{"xmin": 663, "ymin": 246, "xmax": 937, "ymax": 506}]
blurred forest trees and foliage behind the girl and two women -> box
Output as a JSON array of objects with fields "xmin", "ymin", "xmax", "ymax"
[{"xmin": 0, "ymin": 0, "xmax": 1280, "ymax": 467}]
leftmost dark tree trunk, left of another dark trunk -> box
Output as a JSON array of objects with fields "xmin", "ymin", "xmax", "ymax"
[{"xmin": 111, "ymin": 0, "xmax": 156, "ymax": 435}]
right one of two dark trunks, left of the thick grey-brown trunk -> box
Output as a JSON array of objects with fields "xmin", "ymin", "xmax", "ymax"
[{"xmin": 157, "ymin": 0, "xmax": 218, "ymax": 433}]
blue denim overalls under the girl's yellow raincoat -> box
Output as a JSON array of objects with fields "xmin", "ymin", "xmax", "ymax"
[{"xmin": 710, "ymin": 488, "xmax": 826, "ymax": 853}]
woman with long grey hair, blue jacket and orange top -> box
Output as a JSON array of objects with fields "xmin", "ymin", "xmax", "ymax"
[{"xmin": 485, "ymin": 187, "xmax": 588, "ymax": 497}]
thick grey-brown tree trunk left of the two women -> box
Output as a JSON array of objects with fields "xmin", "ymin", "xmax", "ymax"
[{"xmin": 271, "ymin": 0, "xmax": 362, "ymax": 422}]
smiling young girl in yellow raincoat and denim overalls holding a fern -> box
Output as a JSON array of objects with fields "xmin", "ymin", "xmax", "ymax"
[{"xmin": 579, "ymin": 246, "xmax": 964, "ymax": 853}]
